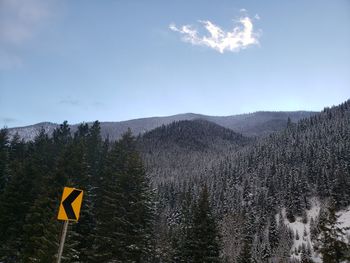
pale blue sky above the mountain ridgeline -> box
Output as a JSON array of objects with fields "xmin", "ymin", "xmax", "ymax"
[{"xmin": 0, "ymin": 0, "xmax": 350, "ymax": 127}]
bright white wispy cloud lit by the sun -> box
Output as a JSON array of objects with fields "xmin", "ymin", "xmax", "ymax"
[{"xmin": 169, "ymin": 16, "xmax": 259, "ymax": 53}]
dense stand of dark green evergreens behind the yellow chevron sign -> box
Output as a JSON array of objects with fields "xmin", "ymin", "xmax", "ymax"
[{"xmin": 0, "ymin": 122, "xmax": 155, "ymax": 262}]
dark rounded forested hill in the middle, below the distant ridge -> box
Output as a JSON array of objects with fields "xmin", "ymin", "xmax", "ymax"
[{"xmin": 138, "ymin": 119, "xmax": 254, "ymax": 185}]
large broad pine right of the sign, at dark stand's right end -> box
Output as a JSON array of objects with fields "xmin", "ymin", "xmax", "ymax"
[{"xmin": 96, "ymin": 131, "xmax": 153, "ymax": 262}]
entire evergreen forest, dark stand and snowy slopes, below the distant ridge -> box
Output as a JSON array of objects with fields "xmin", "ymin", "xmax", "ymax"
[{"xmin": 0, "ymin": 101, "xmax": 350, "ymax": 263}]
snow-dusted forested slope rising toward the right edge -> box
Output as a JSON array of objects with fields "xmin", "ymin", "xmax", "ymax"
[{"xmin": 149, "ymin": 100, "xmax": 350, "ymax": 263}]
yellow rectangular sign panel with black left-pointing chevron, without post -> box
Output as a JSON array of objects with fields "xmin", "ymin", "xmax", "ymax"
[{"xmin": 57, "ymin": 187, "xmax": 83, "ymax": 221}]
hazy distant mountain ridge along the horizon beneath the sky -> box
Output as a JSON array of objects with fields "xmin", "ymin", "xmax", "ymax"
[{"xmin": 9, "ymin": 111, "xmax": 316, "ymax": 141}]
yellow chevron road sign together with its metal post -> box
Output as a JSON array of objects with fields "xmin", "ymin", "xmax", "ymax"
[{"xmin": 57, "ymin": 187, "xmax": 83, "ymax": 263}]
